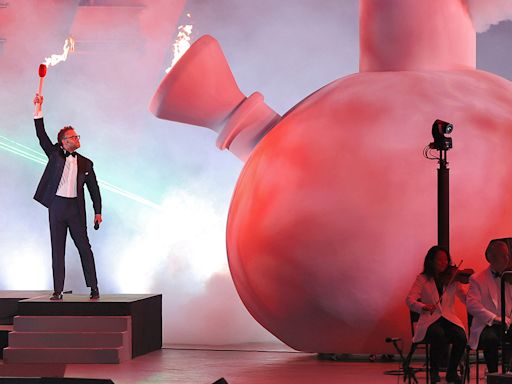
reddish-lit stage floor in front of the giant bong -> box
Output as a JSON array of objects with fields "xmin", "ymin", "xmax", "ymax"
[{"xmin": 0, "ymin": 347, "xmax": 425, "ymax": 384}]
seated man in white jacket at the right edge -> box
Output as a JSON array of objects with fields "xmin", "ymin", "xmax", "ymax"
[{"xmin": 466, "ymin": 240, "xmax": 512, "ymax": 373}]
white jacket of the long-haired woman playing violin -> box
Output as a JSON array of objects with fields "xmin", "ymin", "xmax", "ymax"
[{"xmin": 405, "ymin": 274, "xmax": 466, "ymax": 343}]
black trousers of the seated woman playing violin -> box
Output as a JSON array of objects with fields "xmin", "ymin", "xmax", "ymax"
[{"xmin": 425, "ymin": 317, "xmax": 467, "ymax": 379}]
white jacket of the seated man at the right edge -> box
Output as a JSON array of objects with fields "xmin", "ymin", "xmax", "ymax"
[{"xmin": 466, "ymin": 267, "xmax": 512, "ymax": 349}]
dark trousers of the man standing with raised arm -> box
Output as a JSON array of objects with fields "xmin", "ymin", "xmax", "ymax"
[{"xmin": 48, "ymin": 196, "xmax": 98, "ymax": 292}]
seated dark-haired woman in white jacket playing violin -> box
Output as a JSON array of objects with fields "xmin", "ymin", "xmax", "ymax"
[{"xmin": 406, "ymin": 246, "xmax": 467, "ymax": 384}]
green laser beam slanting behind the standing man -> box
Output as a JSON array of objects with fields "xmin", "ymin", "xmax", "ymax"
[{"xmin": 0, "ymin": 135, "xmax": 161, "ymax": 209}]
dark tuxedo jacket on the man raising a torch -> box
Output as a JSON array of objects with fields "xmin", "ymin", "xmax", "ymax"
[{"xmin": 34, "ymin": 118, "xmax": 101, "ymax": 222}]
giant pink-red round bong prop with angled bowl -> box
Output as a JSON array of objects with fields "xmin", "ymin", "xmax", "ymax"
[{"xmin": 150, "ymin": 0, "xmax": 512, "ymax": 353}]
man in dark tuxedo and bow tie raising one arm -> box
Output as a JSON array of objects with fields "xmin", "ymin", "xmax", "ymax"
[{"xmin": 34, "ymin": 94, "xmax": 102, "ymax": 300}]
